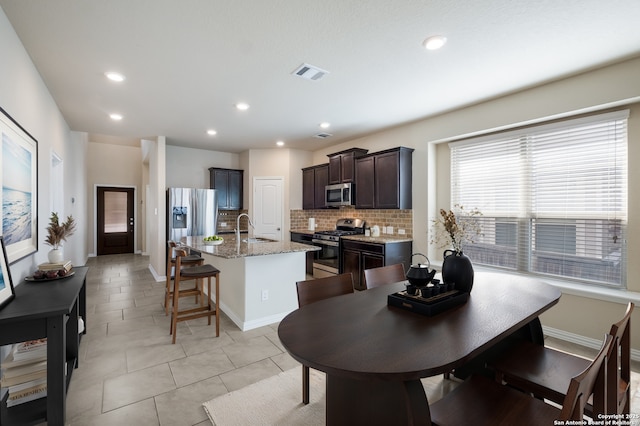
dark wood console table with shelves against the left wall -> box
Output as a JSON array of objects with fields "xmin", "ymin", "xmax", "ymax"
[{"xmin": 0, "ymin": 266, "xmax": 89, "ymax": 426}]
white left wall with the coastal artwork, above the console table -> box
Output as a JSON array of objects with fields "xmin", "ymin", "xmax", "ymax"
[{"xmin": 0, "ymin": 10, "xmax": 87, "ymax": 285}]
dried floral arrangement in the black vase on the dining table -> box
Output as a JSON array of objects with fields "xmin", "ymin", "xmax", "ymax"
[{"xmin": 431, "ymin": 204, "xmax": 482, "ymax": 253}]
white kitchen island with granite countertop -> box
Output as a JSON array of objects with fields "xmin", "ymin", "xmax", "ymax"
[{"xmin": 181, "ymin": 235, "xmax": 319, "ymax": 331}]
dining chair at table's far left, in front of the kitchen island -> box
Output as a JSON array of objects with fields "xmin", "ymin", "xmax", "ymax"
[{"xmin": 296, "ymin": 272, "xmax": 353, "ymax": 404}]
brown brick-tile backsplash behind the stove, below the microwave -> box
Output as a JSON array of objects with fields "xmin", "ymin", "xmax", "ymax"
[{"xmin": 290, "ymin": 207, "xmax": 413, "ymax": 238}]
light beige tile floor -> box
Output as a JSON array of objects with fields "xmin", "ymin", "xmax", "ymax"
[{"xmin": 66, "ymin": 255, "xmax": 640, "ymax": 426}]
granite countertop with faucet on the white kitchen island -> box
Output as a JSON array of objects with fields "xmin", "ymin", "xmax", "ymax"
[{"xmin": 181, "ymin": 234, "xmax": 320, "ymax": 259}]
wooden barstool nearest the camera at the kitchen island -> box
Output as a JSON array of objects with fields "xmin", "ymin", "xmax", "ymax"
[{"xmin": 170, "ymin": 247, "xmax": 220, "ymax": 343}]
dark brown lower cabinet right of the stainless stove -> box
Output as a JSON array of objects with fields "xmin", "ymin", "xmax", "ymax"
[{"xmin": 340, "ymin": 238, "xmax": 412, "ymax": 290}]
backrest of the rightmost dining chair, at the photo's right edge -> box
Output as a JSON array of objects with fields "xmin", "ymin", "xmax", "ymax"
[{"xmin": 606, "ymin": 302, "xmax": 635, "ymax": 414}]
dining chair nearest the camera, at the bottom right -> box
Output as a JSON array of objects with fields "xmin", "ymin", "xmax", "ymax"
[{"xmin": 429, "ymin": 334, "xmax": 613, "ymax": 426}]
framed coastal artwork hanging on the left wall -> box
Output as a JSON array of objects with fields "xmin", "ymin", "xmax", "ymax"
[{"xmin": 0, "ymin": 108, "xmax": 38, "ymax": 264}]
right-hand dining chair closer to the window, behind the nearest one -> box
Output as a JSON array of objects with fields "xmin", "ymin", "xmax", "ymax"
[{"xmin": 488, "ymin": 302, "xmax": 634, "ymax": 416}]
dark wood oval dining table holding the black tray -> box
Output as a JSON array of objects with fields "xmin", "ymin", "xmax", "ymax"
[{"xmin": 278, "ymin": 272, "xmax": 560, "ymax": 425}]
